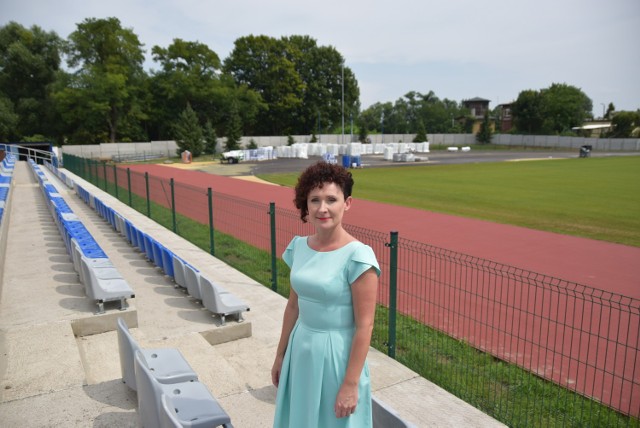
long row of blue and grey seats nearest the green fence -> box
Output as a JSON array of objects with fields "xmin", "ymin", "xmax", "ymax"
[{"xmin": 46, "ymin": 163, "xmax": 250, "ymax": 325}]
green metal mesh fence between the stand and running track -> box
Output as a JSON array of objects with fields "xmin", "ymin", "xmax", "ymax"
[{"xmin": 64, "ymin": 155, "xmax": 640, "ymax": 427}]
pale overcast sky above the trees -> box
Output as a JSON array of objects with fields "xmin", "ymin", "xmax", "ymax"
[{"xmin": 0, "ymin": 0, "xmax": 640, "ymax": 116}]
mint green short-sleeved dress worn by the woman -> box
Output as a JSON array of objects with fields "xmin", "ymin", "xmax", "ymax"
[{"xmin": 273, "ymin": 236, "xmax": 380, "ymax": 428}]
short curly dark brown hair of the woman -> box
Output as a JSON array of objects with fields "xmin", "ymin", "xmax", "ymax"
[{"xmin": 293, "ymin": 161, "xmax": 353, "ymax": 223}]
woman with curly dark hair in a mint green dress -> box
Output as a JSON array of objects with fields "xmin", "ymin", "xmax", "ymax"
[{"xmin": 271, "ymin": 162, "xmax": 380, "ymax": 428}]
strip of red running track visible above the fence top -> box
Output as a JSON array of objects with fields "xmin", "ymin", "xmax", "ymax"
[{"xmin": 130, "ymin": 165, "xmax": 640, "ymax": 299}]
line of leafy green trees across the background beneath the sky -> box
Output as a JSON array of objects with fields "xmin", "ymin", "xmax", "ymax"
[{"xmin": 0, "ymin": 17, "xmax": 640, "ymax": 151}]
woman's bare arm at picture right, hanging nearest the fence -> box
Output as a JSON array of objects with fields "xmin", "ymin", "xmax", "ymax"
[{"xmin": 334, "ymin": 268, "xmax": 378, "ymax": 418}]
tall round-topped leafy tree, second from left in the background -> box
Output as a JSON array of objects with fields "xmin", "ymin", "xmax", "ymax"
[{"xmin": 56, "ymin": 18, "xmax": 146, "ymax": 142}]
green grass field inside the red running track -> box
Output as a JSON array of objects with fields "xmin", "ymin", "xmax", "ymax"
[{"xmin": 260, "ymin": 156, "xmax": 640, "ymax": 247}]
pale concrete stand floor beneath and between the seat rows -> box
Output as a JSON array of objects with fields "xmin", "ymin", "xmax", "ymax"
[{"xmin": 0, "ymin": 162, "xmax": 503, "ymax": 428}]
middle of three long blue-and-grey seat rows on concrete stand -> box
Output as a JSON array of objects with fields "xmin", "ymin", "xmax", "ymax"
[{"xmin": 29, "ymin": 159, "xmax": 135, "ymax": 314}]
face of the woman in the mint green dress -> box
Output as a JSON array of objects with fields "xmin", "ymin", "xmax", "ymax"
[{"xmin": 307, "ymin": 183, "xmax": 351, "ymax": 230}]
